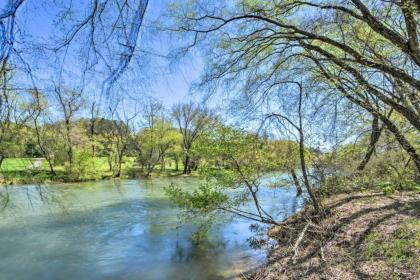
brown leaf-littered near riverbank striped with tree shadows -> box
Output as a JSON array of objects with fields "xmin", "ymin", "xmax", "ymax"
[{"xmin": 244, "ymin": 192, "xmax": 420, "ymax": 280}]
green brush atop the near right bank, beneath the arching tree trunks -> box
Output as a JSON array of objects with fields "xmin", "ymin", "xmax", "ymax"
[{"xmin": 319, "ymin": 124, "xmax": 420, "ymax": 194}]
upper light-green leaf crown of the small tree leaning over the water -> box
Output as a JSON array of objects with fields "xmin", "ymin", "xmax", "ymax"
[{"xmin": 195, "ymin": 125, "xmax": 279, "ymax": 188}]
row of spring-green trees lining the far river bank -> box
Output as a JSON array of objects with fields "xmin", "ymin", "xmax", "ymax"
[{"xmin": 0, "ymin": 80, "xmax": 226, "ymax": 177}]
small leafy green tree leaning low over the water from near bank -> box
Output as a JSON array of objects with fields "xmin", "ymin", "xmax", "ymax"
[{"xmin": 167, "ymin": 124, "xmax": 278, "ymax": 224}]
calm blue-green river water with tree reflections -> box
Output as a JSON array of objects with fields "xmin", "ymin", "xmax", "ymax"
[{"xmin": 0, "ymin": 178, "xmax": 302, "ymax": 280}]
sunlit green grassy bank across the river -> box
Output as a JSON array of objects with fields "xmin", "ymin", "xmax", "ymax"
[{"xmin": 0, "ymin": 157, "xmax": 190, "ymax": 185}]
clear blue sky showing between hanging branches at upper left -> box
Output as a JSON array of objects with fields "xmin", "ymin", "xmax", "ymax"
[{"xmin": 0, "ymin": 0, "xmax": 350, "ymax": 144}]
